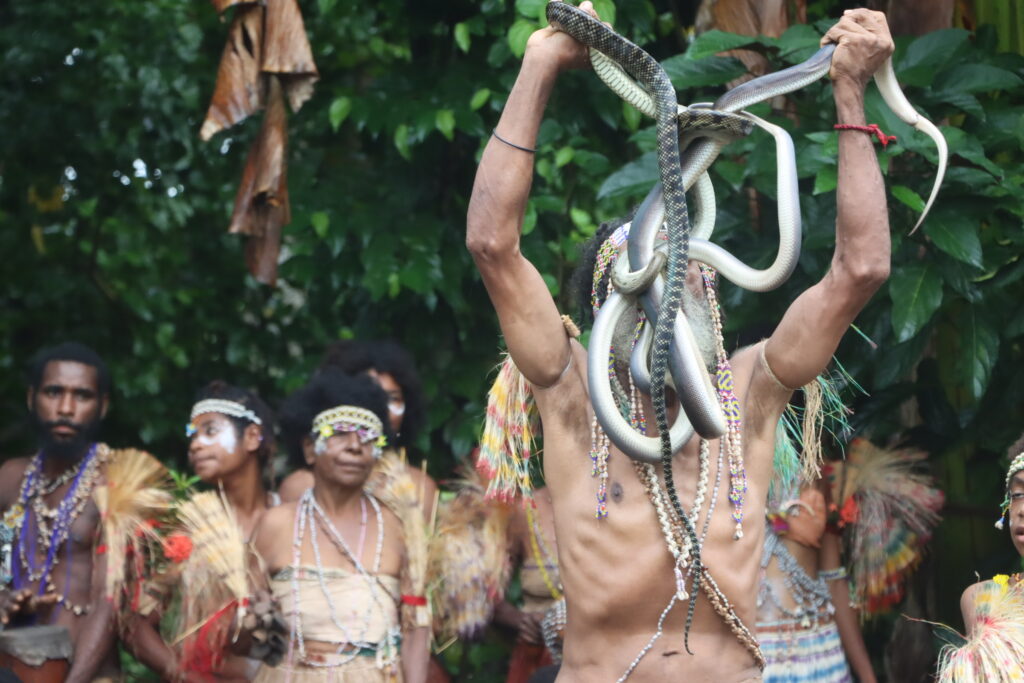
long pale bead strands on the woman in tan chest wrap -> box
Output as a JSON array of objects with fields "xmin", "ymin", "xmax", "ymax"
[{"xmin": 291, "ymin": 488, "xmax": 400, "ymax": 669}]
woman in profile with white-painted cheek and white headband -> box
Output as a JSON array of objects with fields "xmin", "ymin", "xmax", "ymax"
[{"xmin": 126, "ymin": 381, "xmax": 281, "ymax": 681}]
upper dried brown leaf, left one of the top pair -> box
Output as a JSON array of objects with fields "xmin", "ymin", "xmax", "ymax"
[{"xmin": 199, "ymin": 5, "xmax": 264, "ymax": 140}]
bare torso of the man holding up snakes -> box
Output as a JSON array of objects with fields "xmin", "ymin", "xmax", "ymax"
[{"xmin": 536, "ymin": 343, "xmax": 788, "ymax": 683}]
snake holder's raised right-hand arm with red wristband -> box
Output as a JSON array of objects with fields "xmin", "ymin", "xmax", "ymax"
[{"xmin": 765, "ymin": 9, "xmax": 893, "ymax": 387}]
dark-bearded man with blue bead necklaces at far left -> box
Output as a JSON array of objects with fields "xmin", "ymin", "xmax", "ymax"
[{"xmin": 0, "ymin": 342, "xmax": 118, "ymax": 683}]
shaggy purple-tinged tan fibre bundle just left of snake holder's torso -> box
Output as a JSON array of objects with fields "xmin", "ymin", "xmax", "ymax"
[{"xmin": 430, "ymin": 467, "xmax": 511, "ymax": 640}]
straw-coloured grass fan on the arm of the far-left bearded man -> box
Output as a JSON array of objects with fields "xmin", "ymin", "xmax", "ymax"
[{"xmin": 92, "ymin": 449, "xmax": 174, "ymax": 614}]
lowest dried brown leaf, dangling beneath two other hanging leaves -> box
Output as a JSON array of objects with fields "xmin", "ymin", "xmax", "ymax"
[{"xmin": 228, "ymin": 76, "xmax": 292, "ymax": 285}]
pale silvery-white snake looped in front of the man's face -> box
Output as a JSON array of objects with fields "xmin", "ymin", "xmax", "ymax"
[{"xmin": 588, "ymin": 40, "xmax": 948, "ymax": 463}]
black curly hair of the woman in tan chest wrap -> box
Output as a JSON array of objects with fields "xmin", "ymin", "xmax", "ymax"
[{"xmin": 280, "ymin": 366, "xmax": 393, "ymax": 470}]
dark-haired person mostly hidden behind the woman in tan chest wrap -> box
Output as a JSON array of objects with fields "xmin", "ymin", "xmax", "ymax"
[{"xmin": 280, "ymin": 340, "xmax": 437, "ymax": 522}]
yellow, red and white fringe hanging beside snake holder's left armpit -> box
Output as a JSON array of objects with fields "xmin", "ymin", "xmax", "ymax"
[{"xmin": 476, "ymin": 353, "xmax": 540, "ymax": 501}]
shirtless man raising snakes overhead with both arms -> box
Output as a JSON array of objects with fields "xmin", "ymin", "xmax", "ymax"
[{"xmin": 466, "ymin": 2, "xmax": 893, "ymax": 683}]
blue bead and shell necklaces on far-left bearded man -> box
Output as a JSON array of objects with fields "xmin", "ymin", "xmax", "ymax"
[{"xmin": 11, "ymin": 443, "xmax": 105, "ymax": 616}]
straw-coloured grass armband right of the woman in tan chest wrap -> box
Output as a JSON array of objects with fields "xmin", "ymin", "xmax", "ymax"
[{"xmin": 367, "ymin": 451, "xmax": 431, "ymax": 628}]
